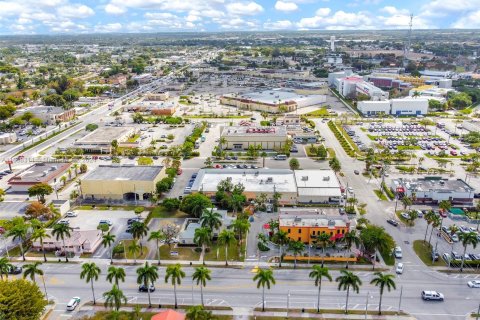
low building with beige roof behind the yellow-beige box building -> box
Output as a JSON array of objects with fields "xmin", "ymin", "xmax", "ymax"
[{"xmin": 74, "ymin": 127, "xmax": 136, "ymax": 153}]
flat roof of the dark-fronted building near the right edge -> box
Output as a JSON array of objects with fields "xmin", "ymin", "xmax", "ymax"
[{"xmin": 394, "ymin": 177, "xmax": 475, "ymax": 192}]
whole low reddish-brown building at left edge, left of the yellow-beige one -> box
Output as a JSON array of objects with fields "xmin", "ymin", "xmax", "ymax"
[{"xmin": 8, "ymin": 162, "xmax": 71, "ymax": 192}]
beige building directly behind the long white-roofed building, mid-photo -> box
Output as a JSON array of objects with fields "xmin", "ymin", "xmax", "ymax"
[{"xmin": 220, "ymin": 126, "xmax": 287, "ymax": 151}]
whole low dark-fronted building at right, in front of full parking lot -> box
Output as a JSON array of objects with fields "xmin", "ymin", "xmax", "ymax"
[{"xmin": 390, "ymin": 177, "xmax": 475, "ymax": 206}]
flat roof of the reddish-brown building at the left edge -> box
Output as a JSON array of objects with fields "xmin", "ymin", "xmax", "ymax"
[{"xmin": 8, "ymin": 162, "xmax": 70, "ymax": 184}]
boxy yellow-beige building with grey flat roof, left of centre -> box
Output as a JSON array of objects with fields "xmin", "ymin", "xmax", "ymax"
[{"xmin": 81, "ymin": 165, "xmax": 166, "ymax": 201}]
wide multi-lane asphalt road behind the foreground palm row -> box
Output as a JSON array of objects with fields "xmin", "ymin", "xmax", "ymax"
[{"xmin": 25, "ymin": 264, "xmax": 480, "ymax": 319}]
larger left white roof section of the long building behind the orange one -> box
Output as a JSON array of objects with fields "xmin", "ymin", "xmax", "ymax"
[{"xmin": 192, "ymin": 169, "xmax": 297, "ymax": 193}]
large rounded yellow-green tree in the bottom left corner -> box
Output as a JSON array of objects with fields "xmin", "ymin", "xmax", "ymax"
[{"xmin": 0, "ymin": 279, "xmax": 48, "ymax": 320}]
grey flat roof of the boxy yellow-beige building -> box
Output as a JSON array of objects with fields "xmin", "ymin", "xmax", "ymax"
[{"xmin": 83, "ymin": 165, "xmax": 163, "ymax": 181}]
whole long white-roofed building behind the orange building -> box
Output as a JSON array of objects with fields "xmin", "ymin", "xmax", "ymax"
[{"xmin": 192, "ymin": 169, "xmax": 342, "ymax": 204}]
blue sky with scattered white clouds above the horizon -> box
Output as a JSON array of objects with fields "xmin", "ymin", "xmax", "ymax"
[{"xmin": 0, "ymin": 0, "xmax": 480, "ymax": 35}]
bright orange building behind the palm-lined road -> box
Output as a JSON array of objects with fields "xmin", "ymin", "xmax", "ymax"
[{"xmin": 279, "ymin": 212, "xmax": 350, "ymax": 244}]
